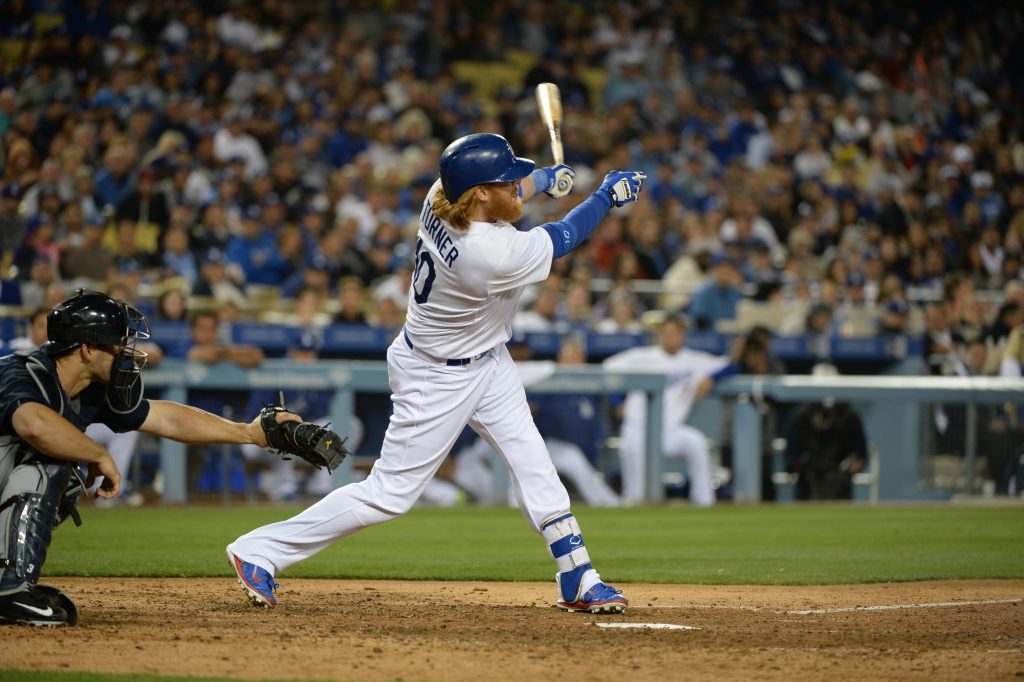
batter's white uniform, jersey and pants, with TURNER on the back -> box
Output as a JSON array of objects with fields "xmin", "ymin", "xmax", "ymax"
[{"xmin": 228, "ymin": 182, "xmax": 600, "ymax": 590}]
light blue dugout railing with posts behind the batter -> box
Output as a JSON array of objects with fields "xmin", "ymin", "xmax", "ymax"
[{"xmin": 138, "ymin": 359, "xmax": 1024, "ymax": 504}]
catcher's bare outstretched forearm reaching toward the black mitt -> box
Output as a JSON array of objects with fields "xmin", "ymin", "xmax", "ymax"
[{"xmin": 139, "ymin": 400, "xmax": 301, "ymax": 447}]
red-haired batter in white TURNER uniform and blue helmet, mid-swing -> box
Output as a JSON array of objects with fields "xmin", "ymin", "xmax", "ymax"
[{"xmin": 227, "ymin": 133, "xmax": 645, "ymax": 613}]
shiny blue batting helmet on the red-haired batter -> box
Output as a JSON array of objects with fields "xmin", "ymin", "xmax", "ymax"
[{"xmin": 441, "ymin": 133, "xmax": 537, "ymax": 204}]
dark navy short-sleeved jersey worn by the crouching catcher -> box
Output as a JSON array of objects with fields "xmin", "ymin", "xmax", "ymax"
[{"xmin": 0, "ymin": 350, "xmax": 150, "ymax": 438}]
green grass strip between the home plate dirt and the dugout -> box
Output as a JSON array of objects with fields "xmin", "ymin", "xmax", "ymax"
[{"xmin": 43, "ymin": 505, "xmax": 1024, "ymax": 585}]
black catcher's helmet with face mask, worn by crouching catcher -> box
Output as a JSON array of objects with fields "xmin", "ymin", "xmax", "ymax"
[{"xmin": 42, "ymin": 289, "xmax": 150, "ymax": 413}]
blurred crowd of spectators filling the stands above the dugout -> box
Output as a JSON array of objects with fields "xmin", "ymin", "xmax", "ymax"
[{"xmin": 0, "ymin": 0, "xmax": 1024, "ymax": 499}]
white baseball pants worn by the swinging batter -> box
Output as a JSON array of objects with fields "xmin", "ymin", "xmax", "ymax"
[{"xmin": 228, "ymin": 336, "xmax": 569, "ymax": 574}]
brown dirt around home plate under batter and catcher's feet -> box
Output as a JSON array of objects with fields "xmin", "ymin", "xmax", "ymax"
[{"xmin": 0, "ymin": 578, "xmax": 1024, "ymax": 682}]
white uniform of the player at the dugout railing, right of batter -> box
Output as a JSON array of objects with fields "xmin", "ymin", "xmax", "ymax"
[{"xmin": 604, "ymin": 345, "xmax": 729, "ymax": 507}]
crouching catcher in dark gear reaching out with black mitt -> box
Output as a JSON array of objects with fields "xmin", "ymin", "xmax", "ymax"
[{"xmin": 0, "ymin": 290, "xmax": 347, "ymax": 626}]
